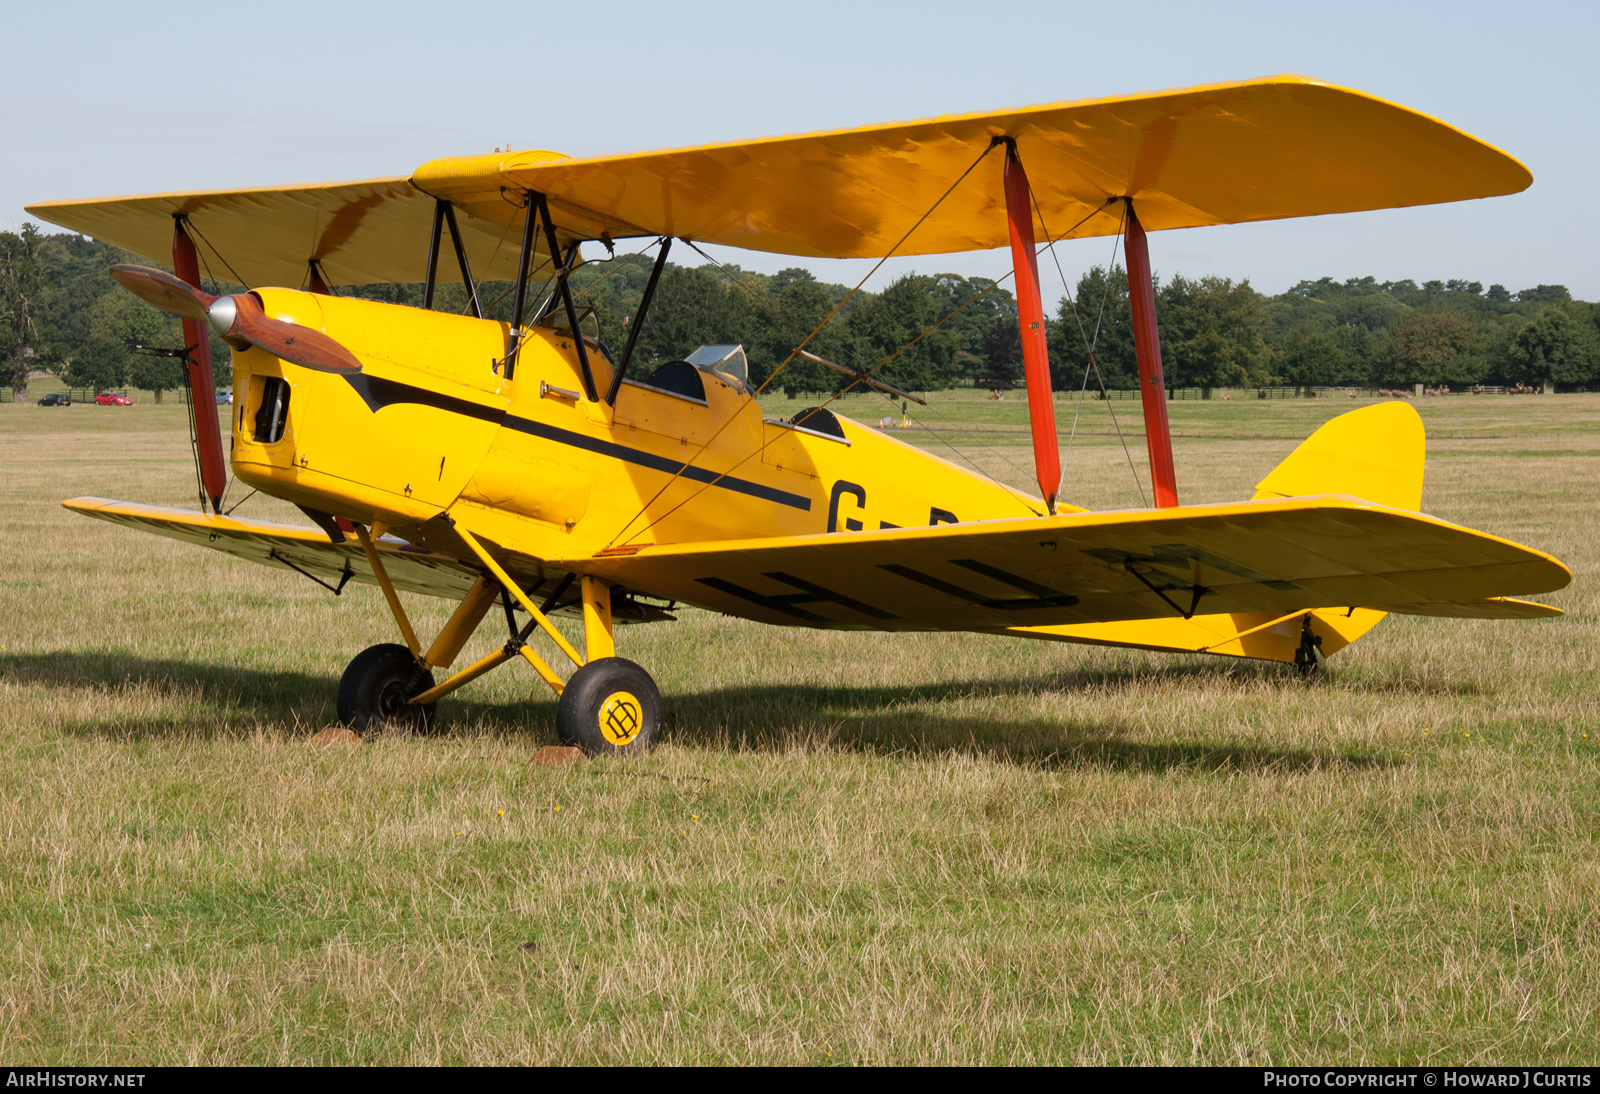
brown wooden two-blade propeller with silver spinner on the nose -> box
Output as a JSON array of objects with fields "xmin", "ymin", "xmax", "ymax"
[{"xmin": 110, "ymin": 266, "xmax": 362, "ymax": 373}]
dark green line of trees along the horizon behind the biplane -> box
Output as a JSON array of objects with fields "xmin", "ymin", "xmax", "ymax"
[{"xmin": 9, "ymin": 226, "xmax": 1600, "ymax": 401}]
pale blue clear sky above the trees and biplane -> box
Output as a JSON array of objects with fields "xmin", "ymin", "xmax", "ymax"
[{"xmin": 0, "ymin": 0, "xmax": 1600, "ymax": 299}]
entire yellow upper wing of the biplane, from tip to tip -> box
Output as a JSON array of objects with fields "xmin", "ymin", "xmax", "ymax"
[{"xmin": 27, "ymin": 75, "xmax": 1533, "ymax": 275}]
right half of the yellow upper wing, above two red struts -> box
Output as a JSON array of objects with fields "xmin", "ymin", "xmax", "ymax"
[{"xmin": 480, "ymin": 75, "xmax": 1533, "ymax": 258}]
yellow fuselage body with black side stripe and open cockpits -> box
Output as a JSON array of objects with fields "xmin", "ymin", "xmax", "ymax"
[{"xmin": 232, "ymin": 289, "xmax": 1043, "ymax": 558}]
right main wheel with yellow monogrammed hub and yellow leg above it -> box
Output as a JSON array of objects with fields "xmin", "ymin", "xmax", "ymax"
[{"xmin": 555, "ymin": 577, "xmax": 662, "ymax": 757}]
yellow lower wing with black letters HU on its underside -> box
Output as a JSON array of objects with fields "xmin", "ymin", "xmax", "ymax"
[{"xmin": 569, "ymin": 496, "xmax": 1571, "ymax": 633}]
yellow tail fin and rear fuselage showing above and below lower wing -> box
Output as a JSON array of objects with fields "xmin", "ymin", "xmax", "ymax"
[{"xmin": 1006, "ymin": 403, "xmax": 1427, "ymax": 664}]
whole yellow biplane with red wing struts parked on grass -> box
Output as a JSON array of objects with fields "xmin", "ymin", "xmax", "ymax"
[{"xmin": 29, "ymin": 75, "xmax": 1571, "ymax": 753}]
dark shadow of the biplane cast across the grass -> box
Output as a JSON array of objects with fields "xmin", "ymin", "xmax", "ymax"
[{"xmin": 0, "ymin": 651, "xmax": 1401, "ymax": 773}]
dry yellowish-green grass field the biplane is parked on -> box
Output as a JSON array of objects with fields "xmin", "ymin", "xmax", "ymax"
[{"xmin": 0, "ymin": 392, "xmax": 1600, "ymax": 1064}]
